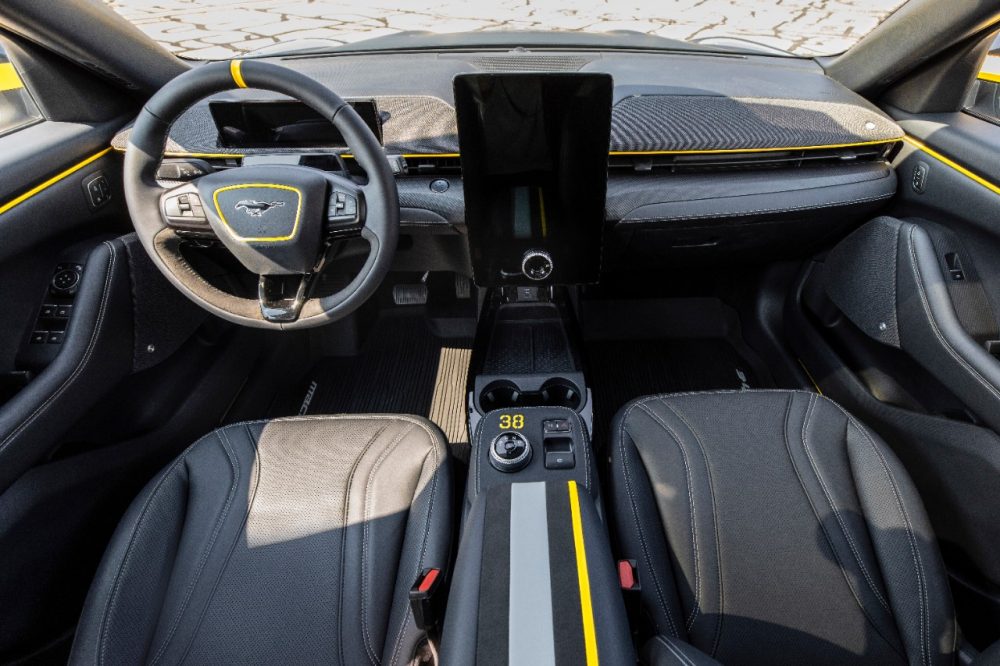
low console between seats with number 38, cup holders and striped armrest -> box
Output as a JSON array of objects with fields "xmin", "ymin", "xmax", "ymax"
[{"xmin": 440, "ymin": 290, "xmax": 635, "ymax": 665}]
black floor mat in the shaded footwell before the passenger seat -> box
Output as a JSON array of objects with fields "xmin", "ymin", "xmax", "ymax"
[{"xmin": 586, "ymin": 338, "xmax": 769, "ymax": 445}]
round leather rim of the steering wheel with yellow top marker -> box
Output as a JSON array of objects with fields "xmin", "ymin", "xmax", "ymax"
[{"xmin": 123, "ymin": 60, "xmax": 399, "ymax": 330}]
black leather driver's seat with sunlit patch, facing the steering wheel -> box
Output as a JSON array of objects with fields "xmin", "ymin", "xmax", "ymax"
[{"xmin": 71, "ymin": 416, "xmax": 452, "ymax": 664}]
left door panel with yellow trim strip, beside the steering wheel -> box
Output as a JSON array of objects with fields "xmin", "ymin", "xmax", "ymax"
[{"xmin": 0, "ymin": 29, "xmax": 265, "ymax": 663}]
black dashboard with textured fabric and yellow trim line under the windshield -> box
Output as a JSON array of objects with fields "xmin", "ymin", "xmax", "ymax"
[{"xmin": 113, "ymin": 50, "xmax": 903, "ymax": 270}]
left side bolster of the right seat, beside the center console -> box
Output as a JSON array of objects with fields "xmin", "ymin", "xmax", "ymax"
[{"xmin": 609, "ymin": 401, "xmax": 687, "ymax": 640}]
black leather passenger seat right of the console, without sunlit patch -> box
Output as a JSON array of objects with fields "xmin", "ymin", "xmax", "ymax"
[{"xmin": 611, "ymin": 391, "xmax": 957, "ymax": 666}]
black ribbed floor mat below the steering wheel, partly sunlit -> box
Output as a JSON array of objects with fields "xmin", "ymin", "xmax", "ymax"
[{"xmin": 272, "ymin": 316, "xmax": 472, "ymax": 443}]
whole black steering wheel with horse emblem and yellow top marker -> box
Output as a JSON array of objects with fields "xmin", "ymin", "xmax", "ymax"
[{"xmin": 124, "ymin": 60, "xmax": 399, "ymax": 329}]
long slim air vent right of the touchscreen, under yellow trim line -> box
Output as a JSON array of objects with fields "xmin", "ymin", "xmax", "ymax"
[{"xmin": 609, "ymin": 141, "xmax": 899, "ymax": 173}]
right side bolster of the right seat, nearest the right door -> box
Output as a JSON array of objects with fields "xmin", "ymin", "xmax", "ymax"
[{"xmin": 847, "ymin": 418, "xmax": 958, "ymax": 666}]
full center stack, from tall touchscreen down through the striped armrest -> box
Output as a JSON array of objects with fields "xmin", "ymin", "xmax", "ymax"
[{"xmin": 440, "ymin": 74, "xmax": 635, "ymax": 665}]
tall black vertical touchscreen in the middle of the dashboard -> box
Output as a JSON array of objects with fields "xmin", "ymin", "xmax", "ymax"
[{"xmin": 455, "ymin": 73, "xmax": 612, "ymax": 285}]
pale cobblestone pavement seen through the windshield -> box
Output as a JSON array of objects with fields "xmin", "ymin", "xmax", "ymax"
[{"xmin": 105, "ymin": 0, "xmax": 904, "ymax": 59}]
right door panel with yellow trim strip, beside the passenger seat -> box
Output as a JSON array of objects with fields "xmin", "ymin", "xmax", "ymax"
[{"xmin": 788, "ymin": 101, "xmax": 1000, "ymax": 645}]
